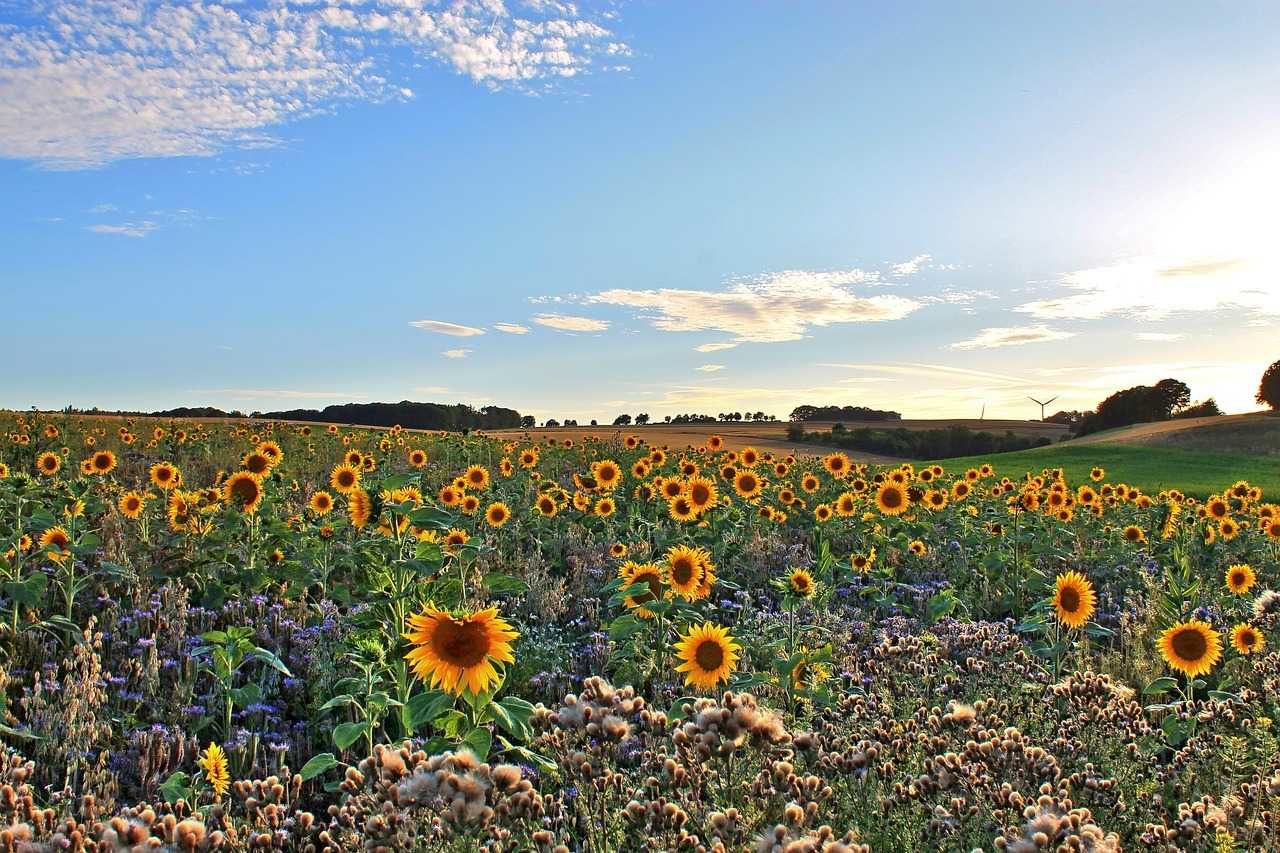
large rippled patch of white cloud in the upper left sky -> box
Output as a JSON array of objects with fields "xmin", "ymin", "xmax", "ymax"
[{"xmin": 0, "ymin": 0, "xmax": 630, "ymax": 168}]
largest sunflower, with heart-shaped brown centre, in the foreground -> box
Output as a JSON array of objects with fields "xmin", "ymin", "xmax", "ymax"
[{"xmin": 404, "ymin": 605, "xmax": 520, "ymax": 695}]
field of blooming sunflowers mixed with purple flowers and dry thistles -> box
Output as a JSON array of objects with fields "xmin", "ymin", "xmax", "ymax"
[{"xmin": 0, "ymin": 412, "xmax": 1280, "ymax": 852}]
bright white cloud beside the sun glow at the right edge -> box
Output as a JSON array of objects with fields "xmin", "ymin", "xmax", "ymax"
[{"xmin": 1015, "ymin": 255, "xmax": 1280, "ymax": 320}]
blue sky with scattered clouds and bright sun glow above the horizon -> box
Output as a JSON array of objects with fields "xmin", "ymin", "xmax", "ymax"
[{"xmin": 0, "ymin": 0, "xmax": 1280, "ymax": 423}]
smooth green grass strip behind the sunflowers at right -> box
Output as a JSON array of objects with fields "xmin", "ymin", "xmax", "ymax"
[{"xmin": 938, "ymin": 444, "xmax": 1280, "ymax": 498}]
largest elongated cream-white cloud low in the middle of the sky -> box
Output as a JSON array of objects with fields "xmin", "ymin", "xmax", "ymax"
[{"xmin": 589, "ymin": 269, "xmax": 920, "ymax": 343}]
